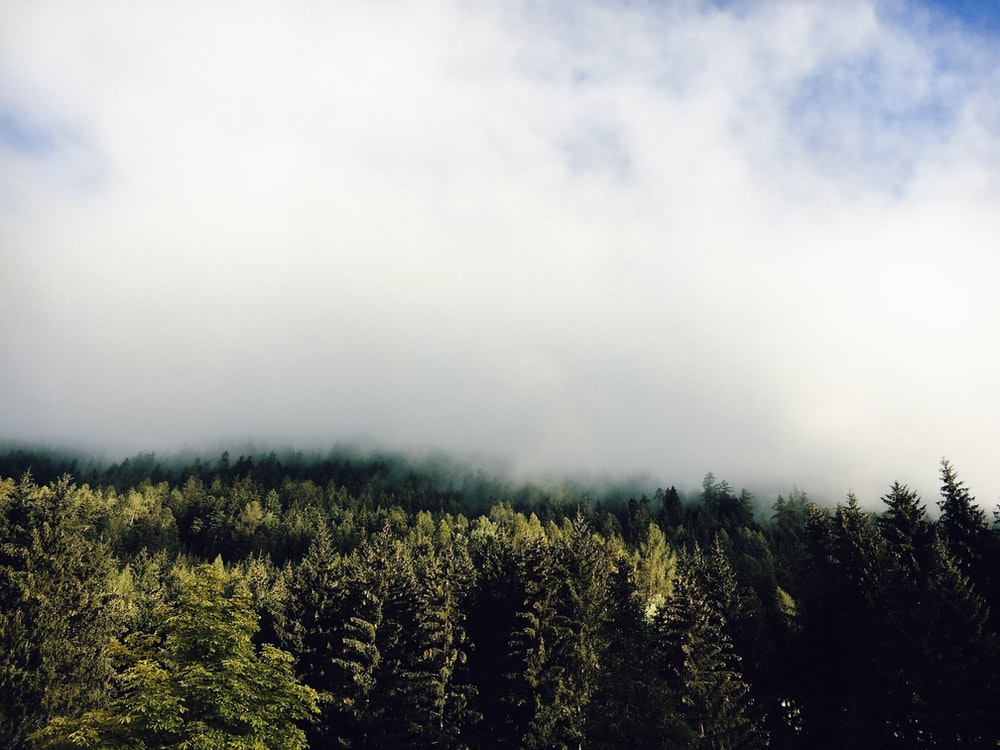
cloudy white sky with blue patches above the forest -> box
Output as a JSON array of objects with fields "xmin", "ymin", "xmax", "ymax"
[{"xmin": 0, "ymin": 0, "xmax": 1000, "ymax": 510}]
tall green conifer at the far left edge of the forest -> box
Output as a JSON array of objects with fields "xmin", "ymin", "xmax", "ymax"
[{"xmin": 0, "ymin": 474, "xmax": 120, "ymax": 750}]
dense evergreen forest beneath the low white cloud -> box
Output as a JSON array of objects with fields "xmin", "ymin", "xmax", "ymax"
[{"xmin": 0, "ymin": 447, "xmax": 1000, "ymax": 750}]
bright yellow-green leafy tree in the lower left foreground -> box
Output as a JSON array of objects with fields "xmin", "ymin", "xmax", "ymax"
[{"xmin": 35, "ymin": 564, "xmax": 316, "ymax": 750}]
